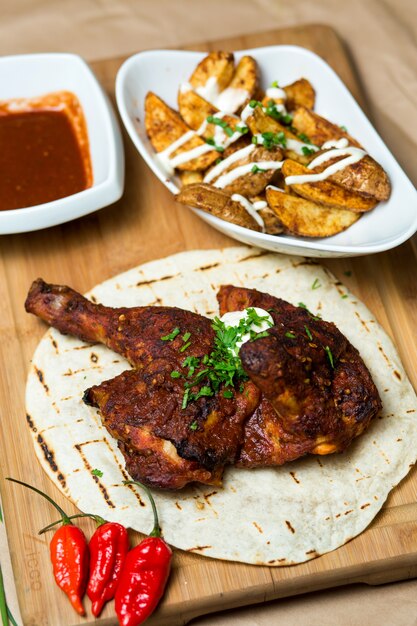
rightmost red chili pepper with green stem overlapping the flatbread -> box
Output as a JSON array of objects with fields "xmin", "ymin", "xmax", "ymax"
[{"xmin": 115, "ymin": 481, "xmax": 172, "ymax": 626}]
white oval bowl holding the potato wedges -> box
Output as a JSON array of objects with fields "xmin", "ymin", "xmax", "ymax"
[{"xmin": 116, "ymin": 46, "xmax": 417, "ymax": 257}]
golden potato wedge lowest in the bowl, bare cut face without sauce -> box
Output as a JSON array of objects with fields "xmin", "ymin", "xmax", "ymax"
[{"xmin": 266, "ymin": 189, "xmax": 360, "ymax": 237}]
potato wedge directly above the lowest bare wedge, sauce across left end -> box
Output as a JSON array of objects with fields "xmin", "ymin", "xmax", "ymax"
[{"xmin": 281, "ymin": 159, "xmax": 378, "ymax": 213}]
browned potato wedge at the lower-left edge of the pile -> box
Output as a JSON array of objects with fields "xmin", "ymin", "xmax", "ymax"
[{"xmin": 175, "ymin": 184, "xmax": 261, "ymax": 231}]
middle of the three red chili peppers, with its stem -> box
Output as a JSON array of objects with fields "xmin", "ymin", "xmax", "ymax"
[{"xmin": 40, "ymin": 513, "xmax": 129, "ymax": 617}]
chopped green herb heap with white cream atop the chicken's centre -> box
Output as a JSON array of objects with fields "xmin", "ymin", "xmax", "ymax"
[{"xmin": 176, "ymin": 308, "xmax": 273, "ymax": 409}]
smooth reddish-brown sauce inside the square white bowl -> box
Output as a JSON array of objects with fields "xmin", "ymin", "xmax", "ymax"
[{"xmin": 0, "ymin": 92, "xmax": 92, "ymax": 211}]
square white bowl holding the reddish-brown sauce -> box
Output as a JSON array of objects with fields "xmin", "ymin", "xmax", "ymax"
[{"xmin": 0, "ymin": 53, "xmax": 124, "ymax": 234}]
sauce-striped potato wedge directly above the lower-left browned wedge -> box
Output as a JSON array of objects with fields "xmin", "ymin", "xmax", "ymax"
[{"xmin": 205, "ymin": 146, "xmax": 282, "ymax": 198}]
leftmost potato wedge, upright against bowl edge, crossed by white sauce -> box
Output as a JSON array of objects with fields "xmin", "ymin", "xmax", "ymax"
[{"xmin": 145, "ymin": 92, "xmax": 219, "ymax": 171}]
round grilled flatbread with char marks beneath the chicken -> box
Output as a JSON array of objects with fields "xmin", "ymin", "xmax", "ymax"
[{"xmin": 26, "ymin": 247, "xmax": 417, "ymax": 566}]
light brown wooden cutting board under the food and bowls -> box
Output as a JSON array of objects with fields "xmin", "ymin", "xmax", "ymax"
[{"xmin": 0, "ymin": 26, "xmax": 417, "ymax": 626}]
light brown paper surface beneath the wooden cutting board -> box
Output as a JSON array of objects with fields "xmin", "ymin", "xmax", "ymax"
[{"xmin": 0, "ymin": 0, "xmax": 417, "ymax": 626}]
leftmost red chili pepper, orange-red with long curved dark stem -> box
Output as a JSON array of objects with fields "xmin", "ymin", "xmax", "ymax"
[{"xmin": 7, "ymin": 478, "xmax": 88, "ymax": 615}]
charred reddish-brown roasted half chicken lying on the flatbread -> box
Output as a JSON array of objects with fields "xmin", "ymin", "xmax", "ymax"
[{"xmin": 25, "ymin": 279, "xmax": 381, "ymax": 489}]
